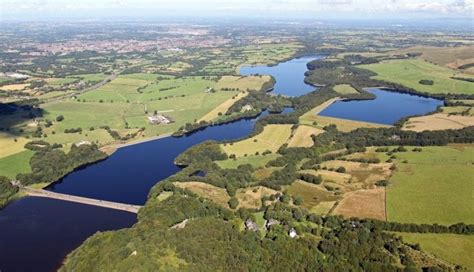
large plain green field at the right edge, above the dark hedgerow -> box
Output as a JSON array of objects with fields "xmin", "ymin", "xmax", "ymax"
[{"xmin": 387, "ymin": 145, "xmax": 474, "ymax": 225}]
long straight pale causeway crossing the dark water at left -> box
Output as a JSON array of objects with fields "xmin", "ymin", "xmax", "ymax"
[{"xmin": 20, "ymin": 186, "xmax": 142, "ymax": 213}]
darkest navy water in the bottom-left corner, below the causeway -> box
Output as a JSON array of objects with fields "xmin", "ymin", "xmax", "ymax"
[{"xmin": 0, "ymin": 197, "xmax": 136, "ymax": 272}]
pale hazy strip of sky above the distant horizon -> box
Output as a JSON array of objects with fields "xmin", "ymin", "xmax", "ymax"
[{"xmin": 0, "ymin": 0, "xmax": 474, "ymax": 20}]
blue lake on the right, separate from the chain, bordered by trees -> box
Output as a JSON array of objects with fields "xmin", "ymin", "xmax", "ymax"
[{"xmin": 319, "ymin": 88, "xmax": 443, "ymax": 125}]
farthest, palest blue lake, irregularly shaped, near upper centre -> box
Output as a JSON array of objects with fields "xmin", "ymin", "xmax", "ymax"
[{"xmin": 240, "ymin": 55, "xmax": 325, "ymax": 96}]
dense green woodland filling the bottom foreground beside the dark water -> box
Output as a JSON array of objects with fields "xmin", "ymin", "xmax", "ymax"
[{"xmin": 62, "ymin": 189, "xmax": 473, "ymax": 271}]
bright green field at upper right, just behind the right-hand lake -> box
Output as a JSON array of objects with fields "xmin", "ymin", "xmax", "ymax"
[{"xmin": 360, "ymin": 59, "xmax": 474, "ymax": 94}]
